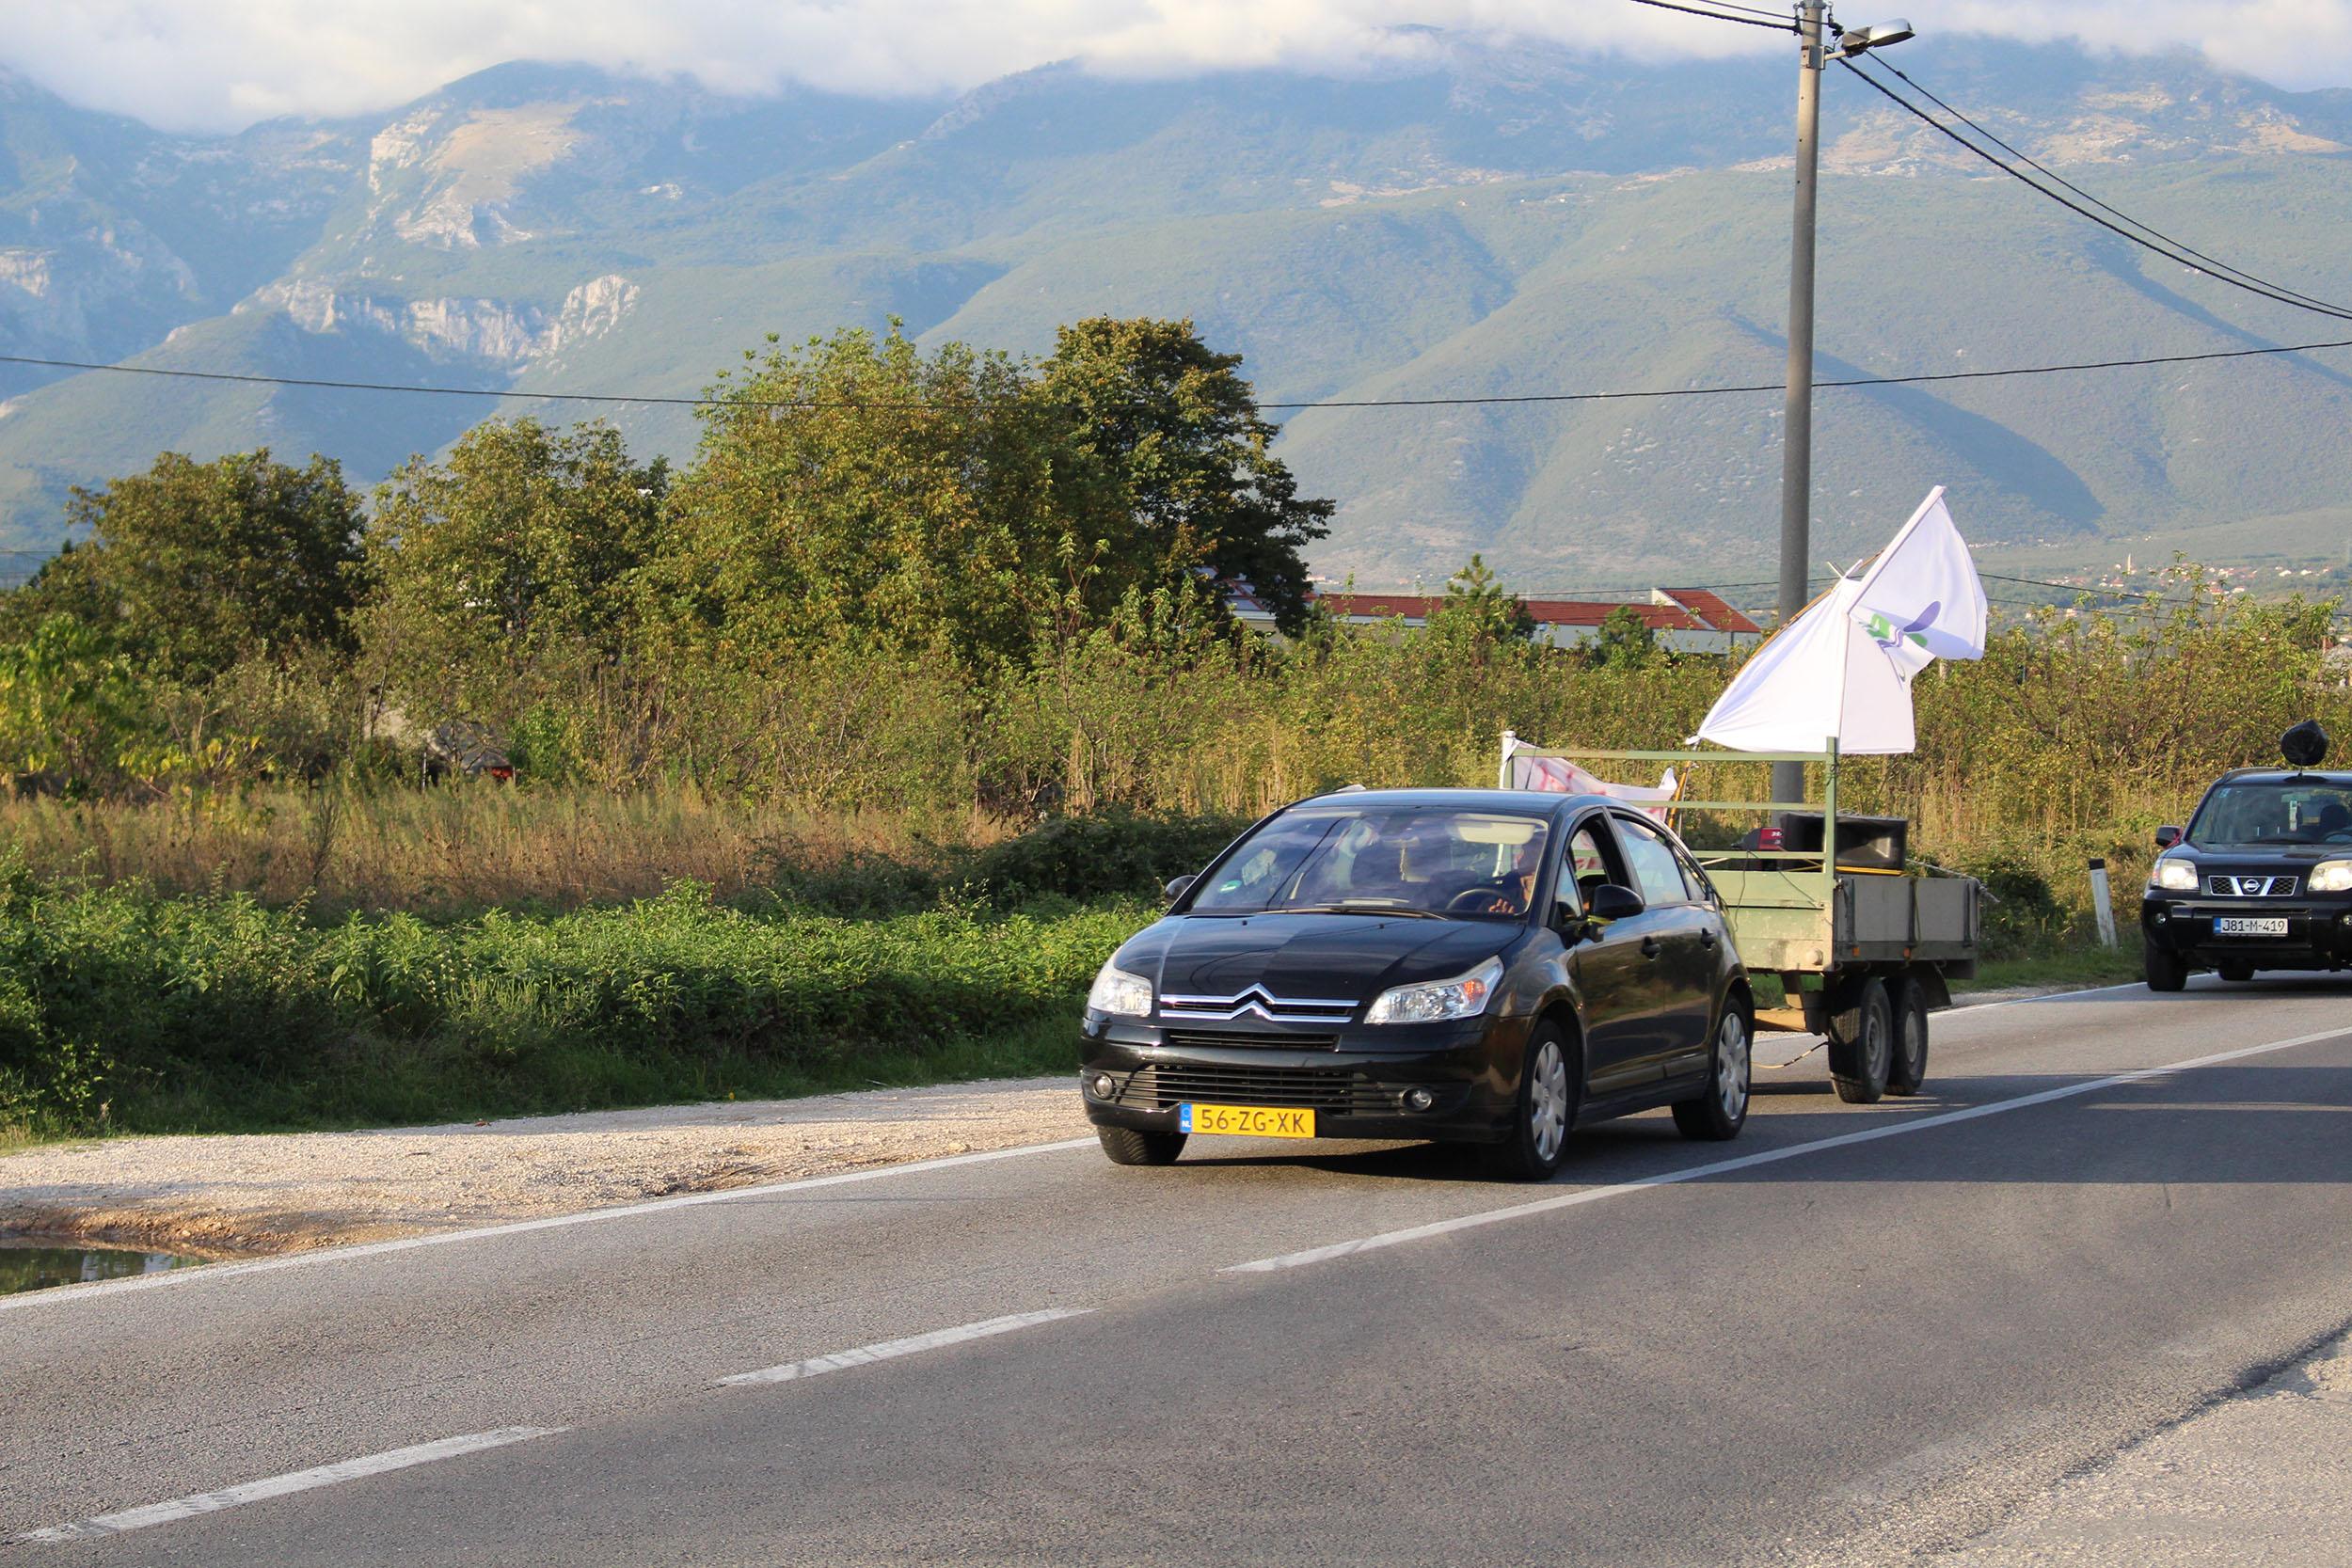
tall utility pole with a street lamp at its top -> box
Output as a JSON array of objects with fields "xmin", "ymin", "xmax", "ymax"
[{"xmin": 1772, "ymin": 0, "xmax": 1913, "ymax": 801}]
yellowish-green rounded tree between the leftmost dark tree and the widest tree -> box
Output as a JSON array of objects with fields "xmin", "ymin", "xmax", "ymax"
[{"xmin": 367, "ymin": 419, "xmax": 671, "ymax": 720}]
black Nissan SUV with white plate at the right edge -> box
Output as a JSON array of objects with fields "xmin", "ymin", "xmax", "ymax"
[{"xmin": 2140, "ymin": 768, "xmax": 2352, "ymax": 992}]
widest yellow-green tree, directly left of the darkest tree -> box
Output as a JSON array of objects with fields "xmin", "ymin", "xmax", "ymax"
[{"xmin": 657, "ymin": 322, "xmax": 1104, "ymax": 665}]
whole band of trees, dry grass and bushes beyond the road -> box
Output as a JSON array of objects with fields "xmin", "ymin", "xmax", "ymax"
[{"xmin": 0, "ymin": 309, "xmax": 2352, "ymax": 1131}]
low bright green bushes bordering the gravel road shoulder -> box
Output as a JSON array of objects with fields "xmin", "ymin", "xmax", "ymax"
[{"xmin": 0, "ymin": 877, "xmax": 1148, "ymax": 1133}]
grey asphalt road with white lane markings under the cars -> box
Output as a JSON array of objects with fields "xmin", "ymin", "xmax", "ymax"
[{"xmin": 0, "ymin": 980, "xmax": 2352, "ymax": 1568}]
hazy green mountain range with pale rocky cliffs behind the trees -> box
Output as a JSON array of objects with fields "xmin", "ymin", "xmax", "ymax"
[{"xmin": 0, "ymin": 30, "xmax": 2352, "ymax": 590}]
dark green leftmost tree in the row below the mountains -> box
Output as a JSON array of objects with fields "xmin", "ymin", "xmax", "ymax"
[{"xmin": 61, "ymin": 449, "xmax": 365, "ymax": 679}]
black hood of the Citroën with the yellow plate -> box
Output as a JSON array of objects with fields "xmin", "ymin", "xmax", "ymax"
[{"xmin": 1118, "ymin": 914, "xmax": 1524, "ymax": 1002}]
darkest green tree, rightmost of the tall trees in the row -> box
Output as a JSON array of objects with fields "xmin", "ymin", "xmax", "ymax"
[{"xmin": 1040, "ymin": 317, "xmax": 1331, "ymax": 632}]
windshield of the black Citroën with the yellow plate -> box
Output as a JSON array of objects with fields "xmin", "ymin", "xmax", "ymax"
[{"xmin": 1193, "ymin": 806, "xmax": 1546, "ymax": 919}]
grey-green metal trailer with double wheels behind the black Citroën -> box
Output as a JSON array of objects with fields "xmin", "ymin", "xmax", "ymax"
[{"xmin": 1499, "ymin": 731, "xmax": 1985, "ymax": 1105}]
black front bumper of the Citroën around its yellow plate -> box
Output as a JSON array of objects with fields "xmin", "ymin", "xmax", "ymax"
[{"xmin": 1080, "ymin": 1013, "xmax": 1534, "ymax": 1143}]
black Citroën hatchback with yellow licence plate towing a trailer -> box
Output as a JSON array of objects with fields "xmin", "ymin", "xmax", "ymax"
[{"xmin": 1080, "ymin": 790, "xmax": 1755, "ymax": 1180}]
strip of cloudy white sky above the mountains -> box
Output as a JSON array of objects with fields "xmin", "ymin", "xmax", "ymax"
[{"xmin": 13, "ymin": 0, "xmax": 2352, "ymax": 129}]
